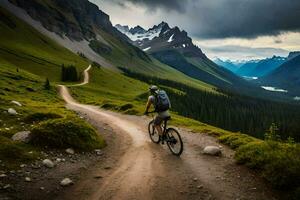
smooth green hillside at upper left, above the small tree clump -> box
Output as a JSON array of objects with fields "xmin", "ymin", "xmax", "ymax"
[{"xmin": 0, "ymin": 7, "xmax": 88, "ymax": 81}]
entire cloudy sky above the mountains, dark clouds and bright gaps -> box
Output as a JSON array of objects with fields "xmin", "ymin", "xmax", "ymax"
[{"xmin": 90, "ymin": 0, "xmax": 300, "ymax": 60}]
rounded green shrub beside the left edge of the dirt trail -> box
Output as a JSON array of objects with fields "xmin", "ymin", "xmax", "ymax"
[{"xmin": 32, "ymin": 118, "xmax": 104, "ymax": 151}]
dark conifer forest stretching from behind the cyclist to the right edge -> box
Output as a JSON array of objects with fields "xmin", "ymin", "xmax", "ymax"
[{"xmin": 121, "ymin": 68, "xmax": 300, "ymax": 142}]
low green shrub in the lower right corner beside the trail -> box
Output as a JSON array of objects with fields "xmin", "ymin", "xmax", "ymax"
[{"xmin": 235, "ymin": 141, "xmax": 300, "ymax": 189}]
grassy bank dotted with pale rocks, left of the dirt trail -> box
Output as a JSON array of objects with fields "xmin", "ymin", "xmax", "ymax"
[{"xmin": 0, "ymin": 65, "xmax": 104, "ymax": 170}]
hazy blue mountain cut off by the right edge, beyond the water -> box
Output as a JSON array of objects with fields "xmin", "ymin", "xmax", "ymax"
[{"xmin": 259, "ymin": 55, "xmax": 300, "ymax": 96}]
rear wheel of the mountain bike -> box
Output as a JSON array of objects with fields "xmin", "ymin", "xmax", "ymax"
[{"xmin": 166, "ymin": 128, "xmax": 183, "ymax": 156}]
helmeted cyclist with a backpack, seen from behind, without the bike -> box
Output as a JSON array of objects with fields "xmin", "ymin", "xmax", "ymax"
[{"xmin": 144, "ymin": 85, "xmax": 171, "ymax": 142}]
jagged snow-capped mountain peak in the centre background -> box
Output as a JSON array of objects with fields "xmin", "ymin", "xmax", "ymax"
[{"xmin": 115, "ymin": 22, "xmax": 253, "ymax": 88}]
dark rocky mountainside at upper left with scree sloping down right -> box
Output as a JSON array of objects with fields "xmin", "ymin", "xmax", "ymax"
[{"xmin": 0, "ymin": 0, "xmax": 214, "ymax": 91}]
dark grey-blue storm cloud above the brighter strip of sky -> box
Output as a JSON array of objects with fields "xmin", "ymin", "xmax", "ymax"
[{"xmin": 109, "ymin": 0, "xmax": 300, "ymax": 38}]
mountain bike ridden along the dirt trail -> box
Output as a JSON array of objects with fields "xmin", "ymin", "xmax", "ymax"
[{"xmin": 148, "ymin": 112, "xmax": 183, "ymax": 156}]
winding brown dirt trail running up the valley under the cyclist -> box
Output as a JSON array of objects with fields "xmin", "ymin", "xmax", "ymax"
[{"xmin": 57, "ymin": 67, "xmax": 276, "ymax": 200}]
